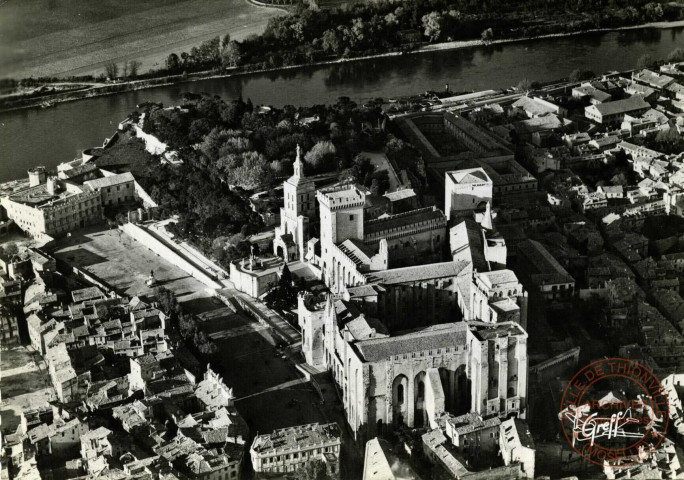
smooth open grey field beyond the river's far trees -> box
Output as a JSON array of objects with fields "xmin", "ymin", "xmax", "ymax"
[{"xmin": 0, "ymin": 0, "xmax": 283, "ymax": 78}]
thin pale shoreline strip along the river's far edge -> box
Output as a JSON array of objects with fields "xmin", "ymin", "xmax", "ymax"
[{"xmin": 0, "ymin": 21, "xmax": 684, "ymax": 112}]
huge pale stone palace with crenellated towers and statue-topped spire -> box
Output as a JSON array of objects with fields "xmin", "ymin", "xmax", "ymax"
[{"xmin": 274, "ymin": 148, "xmax": 527, "ymax": 440}]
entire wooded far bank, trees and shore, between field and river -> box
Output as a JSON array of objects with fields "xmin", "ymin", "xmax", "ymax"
[{"xmin": 0, "ymin": 0, "xmax": 684, "ymax": 109}]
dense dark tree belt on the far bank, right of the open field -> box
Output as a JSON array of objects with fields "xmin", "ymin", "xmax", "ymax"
[{"xmin": 146, "ymin": 0, "xmax": 683, "ymax": 78}]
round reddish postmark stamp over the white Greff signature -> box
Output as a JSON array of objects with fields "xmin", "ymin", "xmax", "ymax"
[{"xmin": 559, "ymin": 358, "xmax": 670, "ymax": 468}]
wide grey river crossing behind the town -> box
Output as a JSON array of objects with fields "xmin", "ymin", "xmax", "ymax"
[{"xmin": 0, "ymin": 27, "xmax": 684, "ymax": 181}]
